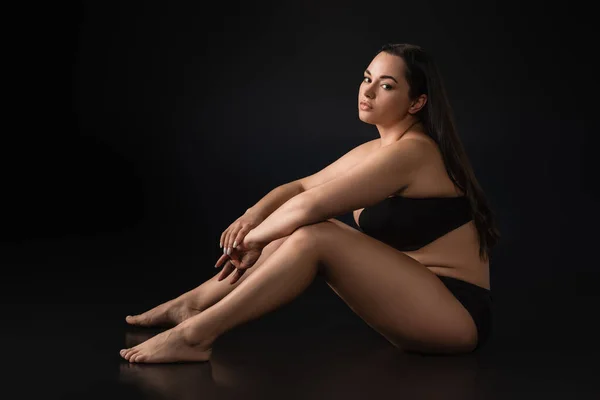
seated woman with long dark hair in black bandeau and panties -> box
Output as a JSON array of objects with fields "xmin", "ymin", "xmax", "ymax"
[{"xmin": 121, "ymin": 44, "xmax": 499, "ymax": 363}]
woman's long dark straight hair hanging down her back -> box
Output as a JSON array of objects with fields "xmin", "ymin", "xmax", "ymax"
[{"xmin": 377, "ymin": 43, "xmax": 500, "ymax": 261}]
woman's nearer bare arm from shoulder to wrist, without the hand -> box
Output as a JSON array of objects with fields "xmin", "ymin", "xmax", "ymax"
[{"xmin": 244, "ymin": 140, "xmax": 428, "ymax": 246}]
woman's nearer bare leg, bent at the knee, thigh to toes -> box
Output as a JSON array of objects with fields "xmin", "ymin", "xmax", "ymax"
[{"xmin": 121, "ymin": 220, "xmax": 477, "ymax": 363}]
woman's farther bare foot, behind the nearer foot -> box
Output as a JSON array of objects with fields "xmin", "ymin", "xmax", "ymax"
[{"xmin": 125, "ymin": 293, "xmax": 202, "ymax": 328}]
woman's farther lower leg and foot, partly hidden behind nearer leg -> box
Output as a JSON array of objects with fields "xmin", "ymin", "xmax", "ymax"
[{"xmin": 125, "ymin": 236, "xmax": 289, "ymax": 327}]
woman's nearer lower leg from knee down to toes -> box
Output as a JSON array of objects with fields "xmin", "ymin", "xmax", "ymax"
[{"xmin": 121, "ymin": 235, "xmax": 319, "ymax": 362}]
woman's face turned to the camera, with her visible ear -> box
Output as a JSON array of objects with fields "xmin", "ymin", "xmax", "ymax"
[{"xmin": 358, "ymin": 52, "xmax": 426, "ymax": 126}]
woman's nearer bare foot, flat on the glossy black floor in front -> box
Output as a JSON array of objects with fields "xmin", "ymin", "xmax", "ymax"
[{"xmin": 120, "ymin": 327, "xmax": 212, "ymax": 363}]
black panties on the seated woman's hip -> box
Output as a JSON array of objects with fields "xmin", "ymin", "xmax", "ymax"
[{"xmin": 437, "ymin": 275, "xmax": 492, "ymax": 349}]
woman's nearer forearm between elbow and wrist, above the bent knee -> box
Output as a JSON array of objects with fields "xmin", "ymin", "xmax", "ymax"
[{"xmin": 243, "ymin": 194, "xmax": 316, "ymax": 246}]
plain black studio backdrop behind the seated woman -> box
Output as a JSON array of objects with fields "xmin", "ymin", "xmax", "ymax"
[{"xmin": 0, "ymin": 1, "xmax": 600, "ymax": 376}]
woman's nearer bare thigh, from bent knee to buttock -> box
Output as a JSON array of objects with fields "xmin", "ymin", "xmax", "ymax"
[{"xmin": 294, "ymin": 221, "xmax": 477, "ymax": 353}]
